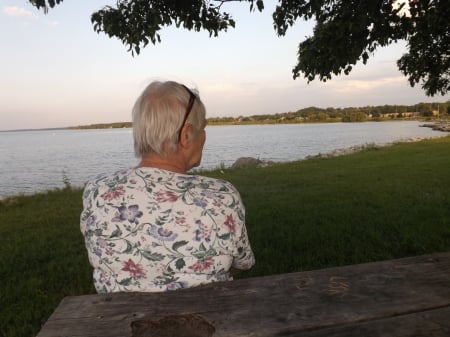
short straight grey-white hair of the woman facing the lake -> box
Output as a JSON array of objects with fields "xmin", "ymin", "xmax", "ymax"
[{"xmin": 132, "ymin": 81, "xmax": 206, "ymax": 157}]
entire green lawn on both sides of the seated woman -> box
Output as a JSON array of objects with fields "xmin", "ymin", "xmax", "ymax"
[{"xmin": 0, "ymin": 137, "xmax": 450, "ymax": 337}]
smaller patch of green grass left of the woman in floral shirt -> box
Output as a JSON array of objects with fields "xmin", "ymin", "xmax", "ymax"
[{"xmin": 0, "ymin": 189, "xmax": 93, "ymax": 337}]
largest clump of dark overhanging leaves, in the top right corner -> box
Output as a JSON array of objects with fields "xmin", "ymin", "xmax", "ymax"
[{"xmin": 273, "ymin": 0, "xmax": 450, "ymax": 96}]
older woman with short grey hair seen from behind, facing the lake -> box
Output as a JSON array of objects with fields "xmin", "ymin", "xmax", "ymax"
[{"xmin": 80, "ymin": 81, "xmax": 255, "ymax": 293}]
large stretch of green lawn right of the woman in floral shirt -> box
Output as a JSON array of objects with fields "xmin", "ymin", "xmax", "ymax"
[{"xmin": 210, "ymin": 137, "xmax": 450, "ymax": 276}]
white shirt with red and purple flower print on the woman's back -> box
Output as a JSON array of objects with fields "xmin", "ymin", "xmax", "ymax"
[{"xmin": 80, "ymin": 168, "xmax": 255, "ymax": 293}]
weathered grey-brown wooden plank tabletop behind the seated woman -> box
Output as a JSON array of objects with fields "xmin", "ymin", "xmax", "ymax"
[{"xmin": 38, "ymin": 253, "xmax": 450, "ymax": 337}]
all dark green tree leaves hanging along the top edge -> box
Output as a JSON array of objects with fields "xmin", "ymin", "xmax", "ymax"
[{"xmin": 28, "ymin": 0, "xmax": 450, "ymax": 96}]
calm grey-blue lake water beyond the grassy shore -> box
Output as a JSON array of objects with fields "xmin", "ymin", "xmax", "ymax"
[{"xmin": 0, "ymin": 122, "xmax": 446, "ymax": 197}]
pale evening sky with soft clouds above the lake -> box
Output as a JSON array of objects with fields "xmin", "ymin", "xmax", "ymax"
[{"xmin": 0, "ymin": 0, "xmax": 450, "ymax": 130}]
